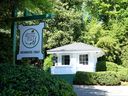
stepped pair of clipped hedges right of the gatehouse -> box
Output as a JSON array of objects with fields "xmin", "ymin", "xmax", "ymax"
[{"xmin": 74, "ymin": 61, "xmax": 128, "ymax": 85}]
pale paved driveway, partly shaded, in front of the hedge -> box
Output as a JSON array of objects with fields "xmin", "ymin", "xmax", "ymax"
[{"xmin": 73, "ymin": 85, "xmax": 128, "ymax": 96}]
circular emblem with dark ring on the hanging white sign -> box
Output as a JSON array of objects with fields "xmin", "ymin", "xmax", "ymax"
[{"xmin": 22, "ymin": 28, "xmax": 40, "ymax": 48}]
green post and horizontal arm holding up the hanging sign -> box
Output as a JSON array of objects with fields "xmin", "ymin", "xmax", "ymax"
[{"xmin": 11, "ymin": 7, "xmax": 55, "ymax": 65}]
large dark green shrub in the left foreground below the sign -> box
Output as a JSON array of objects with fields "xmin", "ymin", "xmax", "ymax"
[{"xmin": 0, "ymin": 64, "xmax": 76, "ymax": 96}]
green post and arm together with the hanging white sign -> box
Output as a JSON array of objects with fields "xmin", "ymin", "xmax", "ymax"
[{"xmin": 9, "ymin": 8, "xmax": 54, "ymax": 65}]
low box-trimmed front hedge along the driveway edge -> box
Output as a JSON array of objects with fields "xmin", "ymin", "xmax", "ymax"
[{"xmin": 74, "ymin": 71, "xmax": 120, "ymax": 85}]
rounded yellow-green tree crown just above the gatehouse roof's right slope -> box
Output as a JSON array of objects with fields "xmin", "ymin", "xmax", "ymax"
[{"xmin": 83, "ymin": 19, "xmax": 107, "ymax": 45}]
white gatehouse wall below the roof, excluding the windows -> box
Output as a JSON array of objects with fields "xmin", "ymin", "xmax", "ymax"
[{"xmin": 51, "ymin": 52, "xmax": 97, "ymax": 74}]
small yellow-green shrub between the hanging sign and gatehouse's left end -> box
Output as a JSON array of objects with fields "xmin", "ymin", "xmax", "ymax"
[{"xmin": 43, "ymin": 55, "xmax": 53, "ymax": 71}]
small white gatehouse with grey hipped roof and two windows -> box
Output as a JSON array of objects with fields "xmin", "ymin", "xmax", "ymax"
[{"xmin": 47, "ymin": 43, "xmax": 104, "ymax": 74}]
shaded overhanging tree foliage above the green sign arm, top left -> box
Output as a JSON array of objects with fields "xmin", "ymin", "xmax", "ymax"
[{"xmin": 0, "ymin": 0, "xmax": 52, "ymax": 29}]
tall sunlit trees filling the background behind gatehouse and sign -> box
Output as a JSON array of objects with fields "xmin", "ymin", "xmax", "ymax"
[{"xmin": 0, "ymin": 0, "xmax": 128, "ymax": 66}]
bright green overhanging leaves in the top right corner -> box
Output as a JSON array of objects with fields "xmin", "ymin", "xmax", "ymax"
[{"xmin": 85, "ymin": 0, "xmax": 128, "ymax": 24}]
